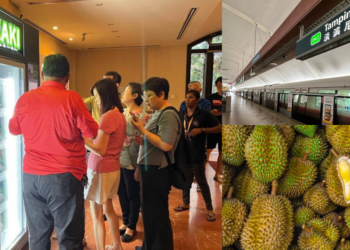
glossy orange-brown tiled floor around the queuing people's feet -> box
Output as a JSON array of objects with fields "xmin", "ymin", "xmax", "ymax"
[{"xmin": 51, "ymin": 152, "xmax": 222, "ymax": 250}]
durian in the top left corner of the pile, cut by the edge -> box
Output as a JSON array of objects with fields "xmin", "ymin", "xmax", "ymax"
[{"xmin": 222, "ymin": 125, "xmax": 252, "ymax": 166}]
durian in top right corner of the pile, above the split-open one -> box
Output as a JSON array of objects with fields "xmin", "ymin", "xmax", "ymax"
[{"xmin": 326, "ymin": 125, "xmax": 350, "ymax": 155}]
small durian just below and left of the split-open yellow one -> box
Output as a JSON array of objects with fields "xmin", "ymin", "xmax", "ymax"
[{"xmin": 304, "ymin": 181, "xmax": 337, "ymax": 215}]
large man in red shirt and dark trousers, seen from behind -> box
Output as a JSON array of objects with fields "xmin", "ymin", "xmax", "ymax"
[{"xmin": 9, "ymin": 54, "xmax": 98, "ymax": 250}]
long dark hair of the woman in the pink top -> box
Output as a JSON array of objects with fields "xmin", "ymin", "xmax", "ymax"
[{"xmin": 90, "ymin": 78, "xmax": 124, "ymax": 114}]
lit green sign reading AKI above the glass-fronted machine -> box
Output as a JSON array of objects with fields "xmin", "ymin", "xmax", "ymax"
[{"xmin": 0, "ymin": 9, "xmax": 23, "ymax": 55}]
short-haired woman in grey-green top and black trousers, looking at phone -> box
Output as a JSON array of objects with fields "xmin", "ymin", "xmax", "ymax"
[{"xmin": 131, "ymin": 77, "xmax": 182, "ymax": 250}]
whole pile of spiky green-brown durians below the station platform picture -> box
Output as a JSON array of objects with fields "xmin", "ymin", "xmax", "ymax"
[{"xmin": 222, "ymin": 125, "xmax": 350, "ymax": 250}]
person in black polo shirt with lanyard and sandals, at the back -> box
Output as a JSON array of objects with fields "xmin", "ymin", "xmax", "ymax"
[{"xmin": 174, "ymin": 90, "xmax": 221, "ymax": 221}]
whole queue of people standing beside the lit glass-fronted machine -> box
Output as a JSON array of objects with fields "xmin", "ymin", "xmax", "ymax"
[{"xmin": 9, "ymin": 54, "xmax": 222, "ymax": 250}]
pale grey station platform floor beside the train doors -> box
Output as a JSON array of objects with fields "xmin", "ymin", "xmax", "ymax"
[{"xmin": 222, "ymin": 94, "xmax": 303, "ymax": 125}]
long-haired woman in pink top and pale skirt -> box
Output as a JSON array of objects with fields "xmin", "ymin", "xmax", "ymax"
[{"xmin": 85, "ymin": 78, "xmax": 126, "ymax": 250}]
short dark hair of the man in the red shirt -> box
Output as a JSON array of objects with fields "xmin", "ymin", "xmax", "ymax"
[{"xmin": 42, "ymin": 54, "xmax": 69, "ymax": 78}]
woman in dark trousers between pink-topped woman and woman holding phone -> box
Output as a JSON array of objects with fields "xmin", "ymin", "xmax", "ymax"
[{"xmin": 118, "ymin": 82, "xmax": 150, "ymax": 242}]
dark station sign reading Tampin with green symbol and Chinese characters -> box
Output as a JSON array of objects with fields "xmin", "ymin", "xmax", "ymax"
[{"xmin": 296, "ymin": 7, "xmax": 350, "ymax": 60}]
